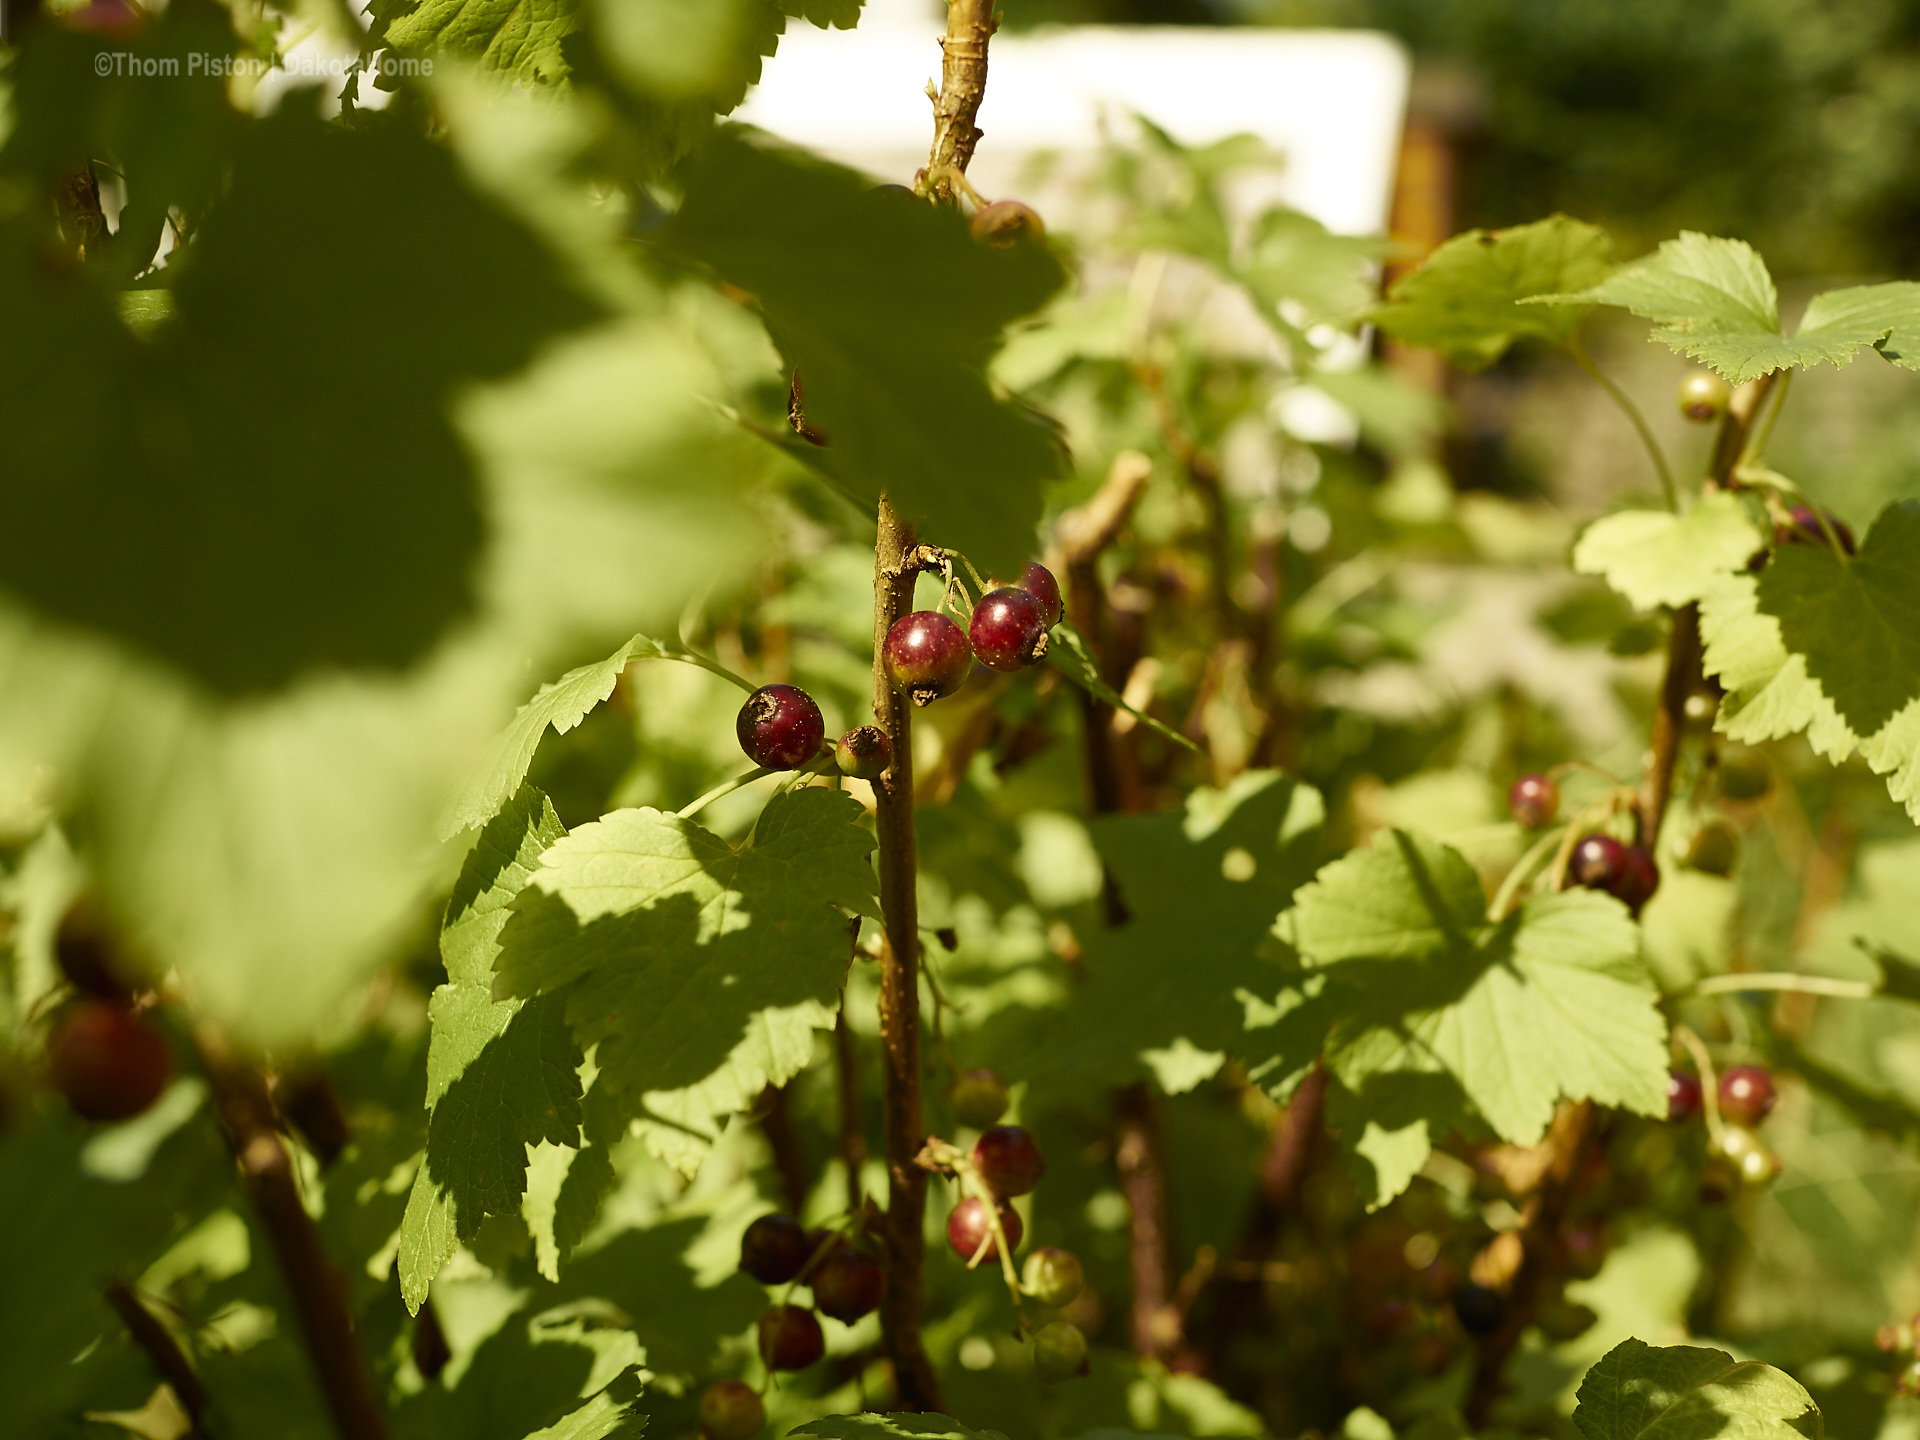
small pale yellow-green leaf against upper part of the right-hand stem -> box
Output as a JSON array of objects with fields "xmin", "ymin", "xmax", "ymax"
[{"xmin": 1572, "ymin": 490, "xmax": 1766, "ymax": 611}]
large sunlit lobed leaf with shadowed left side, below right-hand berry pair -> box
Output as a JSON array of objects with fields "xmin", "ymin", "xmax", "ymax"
[{"xmin": 1275, "ymin": 831, "xmax": 1667, "ymax": 1200}]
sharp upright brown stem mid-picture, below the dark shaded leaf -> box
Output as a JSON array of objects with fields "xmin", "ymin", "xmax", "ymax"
[{"xmin": 874, "ymin": 499, "xmax": 941, "ymax": 1409}]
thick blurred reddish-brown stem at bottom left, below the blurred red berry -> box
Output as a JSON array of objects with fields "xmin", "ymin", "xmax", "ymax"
[{"xmin": 194, "ymin": 1025, "xmax": 386, "ymax": 1440}]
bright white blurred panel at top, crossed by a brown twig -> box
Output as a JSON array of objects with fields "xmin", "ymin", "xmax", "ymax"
[{"xmin": 735, "ymin": 0, "xmax": 1407, "ymax": 234}]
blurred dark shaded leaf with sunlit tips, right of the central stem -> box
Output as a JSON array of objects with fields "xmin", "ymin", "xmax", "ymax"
[{"xmin": 1031, "ymin": 770, "xmax": 1325, "ymax": 1089}]
